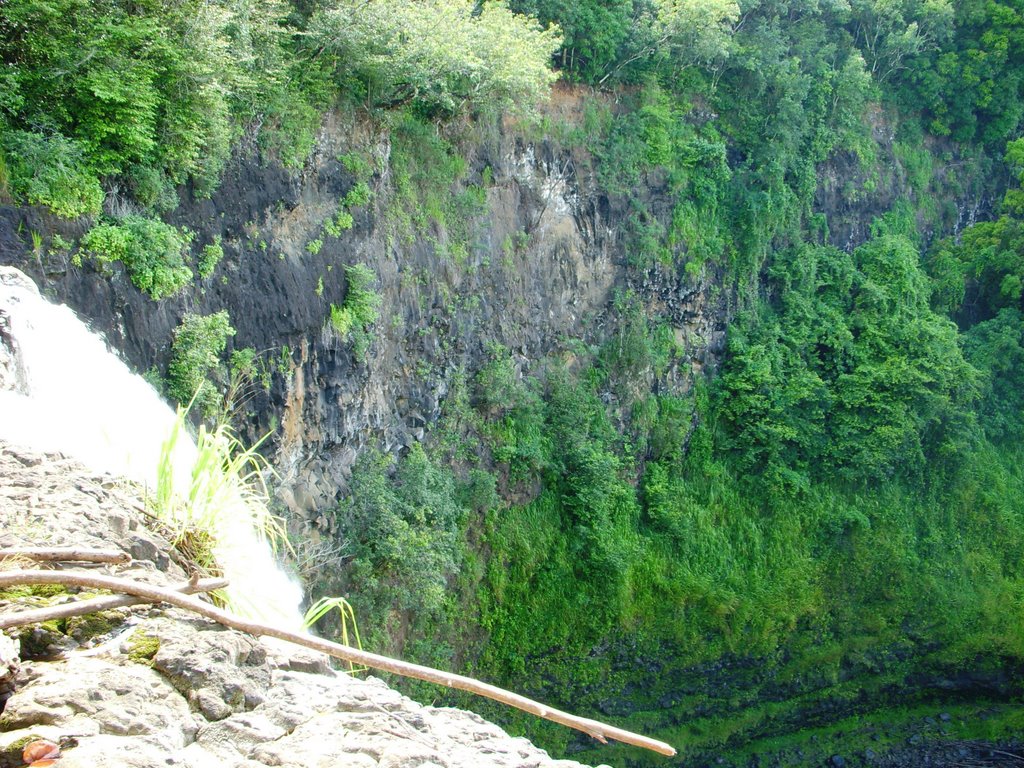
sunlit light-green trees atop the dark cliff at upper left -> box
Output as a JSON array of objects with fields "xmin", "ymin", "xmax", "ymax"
[{"xmin": 0, "ymin": 0, "xmax": 559, "ymax": 224}]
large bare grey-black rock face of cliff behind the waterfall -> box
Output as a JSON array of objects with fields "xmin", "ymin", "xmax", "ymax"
[{"xmin": 0, "ymin": 105, "xmax": 725, "ymax": 525}]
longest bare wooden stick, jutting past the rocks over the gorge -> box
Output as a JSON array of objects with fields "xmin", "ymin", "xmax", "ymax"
[{"xmin": 0, "ymin": 570, "xmax": 676, "ymax": 757}]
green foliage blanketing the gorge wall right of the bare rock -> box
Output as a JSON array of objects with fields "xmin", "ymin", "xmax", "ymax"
[{"xmin": 296, "ymin": 0, "xmax": 1024, "ymax": 764}]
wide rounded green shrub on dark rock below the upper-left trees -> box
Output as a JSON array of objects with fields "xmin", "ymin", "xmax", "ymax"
[{"xmin": 82, "ymin": 215, "xmax": 193, "ymax": 301}]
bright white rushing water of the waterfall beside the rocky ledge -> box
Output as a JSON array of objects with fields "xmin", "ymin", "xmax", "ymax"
[{"xmin": 0, "ymin": 267, "xmax": 302, "ymax": 630}]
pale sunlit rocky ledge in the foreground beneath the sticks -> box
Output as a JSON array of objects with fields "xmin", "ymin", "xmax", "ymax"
[{"xmin": 0, "ymin": 442, "xmax": 598, "ymax": 768}]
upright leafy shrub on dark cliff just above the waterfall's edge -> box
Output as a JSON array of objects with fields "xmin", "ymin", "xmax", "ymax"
[{"xmin": 167, "ymin": 309, "xmax": 234, "ymax": 417}]
